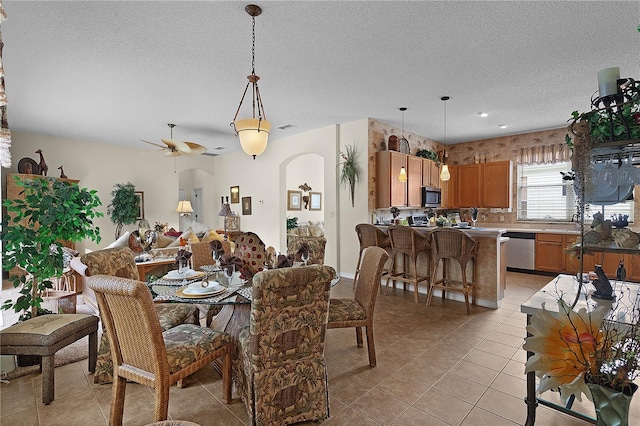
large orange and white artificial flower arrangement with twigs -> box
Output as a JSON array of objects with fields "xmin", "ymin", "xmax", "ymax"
[{"xmin": 523, "ymin": 283, "xmax": 640, "ymax": 402}]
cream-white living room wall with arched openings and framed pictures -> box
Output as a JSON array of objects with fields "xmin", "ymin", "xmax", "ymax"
[{"xmin": 2, "ymin": 119, "xmax": 368, "ymax": 276}]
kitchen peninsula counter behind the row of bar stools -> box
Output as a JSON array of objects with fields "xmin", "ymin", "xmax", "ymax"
[{"xmin": 376, "ymin": 225, "xmax": 508, "ymax": 309}]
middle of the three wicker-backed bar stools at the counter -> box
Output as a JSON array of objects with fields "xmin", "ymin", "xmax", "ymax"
[{"xmin": 385, "ymin": 225, "xmax": 431, "ymax": 303}]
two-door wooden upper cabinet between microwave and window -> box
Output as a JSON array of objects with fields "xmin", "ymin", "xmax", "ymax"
[{"xmin": 455, "ymin": 161, "xmax": 513, "ymax": 208}]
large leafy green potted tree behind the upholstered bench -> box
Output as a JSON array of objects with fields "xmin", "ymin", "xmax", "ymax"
[{"xmin": 0, "ymin": 176, "xmax": 103, "ymax": 320}]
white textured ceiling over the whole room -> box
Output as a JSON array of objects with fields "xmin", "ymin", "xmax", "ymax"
[{"xmin": 2, "ymin": 0, "xmax": 640, "ymax": 153}]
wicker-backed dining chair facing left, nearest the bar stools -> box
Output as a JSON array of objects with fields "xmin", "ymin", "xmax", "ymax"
[{"xmin": 327, "ymin": 246, "xmax": 389, "ymax": 367}]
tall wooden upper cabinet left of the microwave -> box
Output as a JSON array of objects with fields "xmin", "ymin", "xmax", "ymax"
[{"xmin": 376, "ymin": 151, "xmax": 423, "ymax": 208}]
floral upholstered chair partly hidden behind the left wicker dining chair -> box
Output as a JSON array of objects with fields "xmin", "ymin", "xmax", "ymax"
[{"xmin": 80, "ymin": 247, "xmax": 200, "ymax": 383}]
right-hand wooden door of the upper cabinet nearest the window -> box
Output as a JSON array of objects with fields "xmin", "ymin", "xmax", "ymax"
[{"xmin": 480, "ymin": 161, "xmax": 512, "ymax": 208}]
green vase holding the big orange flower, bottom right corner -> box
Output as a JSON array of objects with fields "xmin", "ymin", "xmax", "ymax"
[{"xmin": 587, "ymin": 383, "xmax": 638, "ymax": 426}]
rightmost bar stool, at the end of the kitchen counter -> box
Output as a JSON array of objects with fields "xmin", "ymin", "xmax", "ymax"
[{"xmin": 427, "ymin": 228, "xmax": 478, "ymax": 315}]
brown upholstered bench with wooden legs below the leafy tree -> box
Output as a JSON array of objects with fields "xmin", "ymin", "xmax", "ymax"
[{"xmin": 0, "ymin": 314, "xmax": 99, "ymax": 404}]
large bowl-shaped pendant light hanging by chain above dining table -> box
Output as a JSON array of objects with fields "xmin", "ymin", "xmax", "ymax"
[{"xmin": 231, "ymin": 4, "xmax": 271, "ymax": 160}]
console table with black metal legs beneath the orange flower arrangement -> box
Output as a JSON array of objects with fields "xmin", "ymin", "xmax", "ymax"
[{"xmin": 520, "ymin": 275, "xmax": 640, "ymax": 426}]
